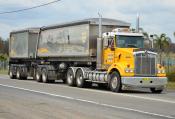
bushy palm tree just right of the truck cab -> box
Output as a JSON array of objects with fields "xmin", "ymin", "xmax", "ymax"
[{"xmin": 153, "ymin": 33, "xmax": 171, "ymax": 64}]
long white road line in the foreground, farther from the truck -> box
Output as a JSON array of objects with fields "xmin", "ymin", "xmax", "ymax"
[{"xmin": 0, "ymin": 84, "xmax": 175, "ymax": 119}]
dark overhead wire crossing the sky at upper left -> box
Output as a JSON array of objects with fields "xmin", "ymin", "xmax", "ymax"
[{"xmin": 0, "ymin": 0, "xmax": 61, "ymax": 15}]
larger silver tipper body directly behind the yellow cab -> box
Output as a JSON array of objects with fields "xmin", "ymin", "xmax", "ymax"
[{"xmin": 37, "ymin": 18, "xmax": 130, "ymax": 60}]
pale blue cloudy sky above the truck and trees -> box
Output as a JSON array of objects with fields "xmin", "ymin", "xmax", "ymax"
[{"xmin": 0, "ymin": 0, "xmax": 175, "ymax": 42}]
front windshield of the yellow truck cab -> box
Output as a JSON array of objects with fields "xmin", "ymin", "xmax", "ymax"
[{"xmin": 117, "ymin": 36, "xmax": 144, "ymax": 48}]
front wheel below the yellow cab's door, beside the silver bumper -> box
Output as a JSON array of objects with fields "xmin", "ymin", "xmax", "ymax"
[{"xmin": 109, "ymin": 72, "xmax": 122, "ymax": 92}]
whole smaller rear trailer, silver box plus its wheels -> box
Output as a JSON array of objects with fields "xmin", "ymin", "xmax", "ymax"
[{"xmin": 9, "ymin": 28, "xmax": 39, "ymax": 79}]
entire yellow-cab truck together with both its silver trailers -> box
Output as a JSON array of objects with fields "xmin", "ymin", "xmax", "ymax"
[{"xmin": 9, "ymin": 18, "xmax": 167, "ymax": 93}]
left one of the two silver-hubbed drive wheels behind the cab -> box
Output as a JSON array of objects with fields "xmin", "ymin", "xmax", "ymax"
[{"xmin": 67, "ymin": 68, "xmax": 75, "ymax": 86}]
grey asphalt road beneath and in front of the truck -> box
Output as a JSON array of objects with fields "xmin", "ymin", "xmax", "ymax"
[{"xmin": 0, "ymin": 75, "xmax": 175, "ymax": 119}]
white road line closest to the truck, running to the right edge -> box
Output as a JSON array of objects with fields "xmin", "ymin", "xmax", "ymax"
[{"xmin": 0, "ymin": 75, "xmax": 175, "ymax": 104}]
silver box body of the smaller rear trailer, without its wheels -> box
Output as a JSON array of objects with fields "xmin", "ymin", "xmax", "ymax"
[{"xmin": 9, "ymin": 28, "xmax": 39, "ymax": 58}]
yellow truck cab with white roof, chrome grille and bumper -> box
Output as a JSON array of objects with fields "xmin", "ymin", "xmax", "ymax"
[{"xmin": 102, "ymin": 28, "xmax": 167, "ymax": 93}]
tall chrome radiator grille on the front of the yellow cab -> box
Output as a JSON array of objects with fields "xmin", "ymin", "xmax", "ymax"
[{"xmin": 135, "ymin": 52, "xmax": 156, "ymax": 76}]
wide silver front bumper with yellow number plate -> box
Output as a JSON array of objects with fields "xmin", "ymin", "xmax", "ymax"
[{"xmin": 121, "ymin": 77, "xmax": 167, "ymax": 88}]
